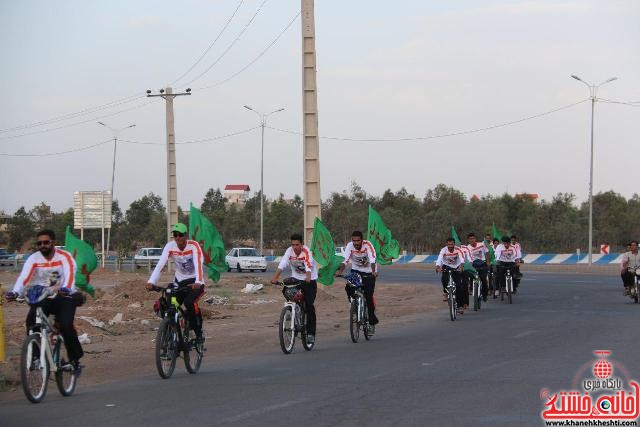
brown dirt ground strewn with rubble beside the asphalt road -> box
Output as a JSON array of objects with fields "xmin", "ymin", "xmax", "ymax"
[{"xmin": 0, "ymin": 271, "xmax": 443, "ymax": 396}]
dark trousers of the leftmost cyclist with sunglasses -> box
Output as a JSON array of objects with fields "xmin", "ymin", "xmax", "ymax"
[{"xmin": 26, "ymin": 295, "xmax": 84, "ymax": 361}]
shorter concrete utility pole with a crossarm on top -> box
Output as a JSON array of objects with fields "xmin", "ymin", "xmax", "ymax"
[{"xmin": 147, "ymin": 87, "xmax": 191, "ymax": 241}]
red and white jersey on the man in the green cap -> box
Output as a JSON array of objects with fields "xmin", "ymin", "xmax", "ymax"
[{"xmin": 149, "ymin": 240, "xmax": 205, "ymax": 285}]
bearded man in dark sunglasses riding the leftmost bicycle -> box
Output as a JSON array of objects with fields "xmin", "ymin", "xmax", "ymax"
[{"xmin": 5, "ymin": 230, "xmax": 84, "ymax": 376}]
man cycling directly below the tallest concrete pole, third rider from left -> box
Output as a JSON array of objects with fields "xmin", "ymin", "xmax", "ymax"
[{"xmin": 271, "ymin": 233, "xmax": 318, "ymax": 344}]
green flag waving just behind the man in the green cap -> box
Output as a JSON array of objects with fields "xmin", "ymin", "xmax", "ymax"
[{"xmin": 189, "ymin": 205, "xmax": 227, "ymax": 282}]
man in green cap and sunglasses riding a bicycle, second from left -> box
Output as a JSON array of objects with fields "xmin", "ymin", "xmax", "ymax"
[{"xmin": 146, "ymin": 222, "xmax": 205, "ymax": 344}]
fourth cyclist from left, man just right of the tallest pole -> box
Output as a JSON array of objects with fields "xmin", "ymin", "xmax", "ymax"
[{"xmin": 336, "ymin": 230, "xmax": 378, "ymax": 334}]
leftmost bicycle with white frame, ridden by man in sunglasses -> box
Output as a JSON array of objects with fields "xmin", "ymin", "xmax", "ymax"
[{"xmin": 15, "ymin": 285, "xmax": 78, "ymax": 403}]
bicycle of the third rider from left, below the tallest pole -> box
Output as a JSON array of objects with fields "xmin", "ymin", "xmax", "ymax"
[{"xmin": 278, "ymin": 277, "xmax": 315, "ymax": 354}]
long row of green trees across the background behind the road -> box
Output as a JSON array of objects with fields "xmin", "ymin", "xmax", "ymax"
[{"xmin": 0, "ymin": 183, "xmax": 640, "ymax": 254}]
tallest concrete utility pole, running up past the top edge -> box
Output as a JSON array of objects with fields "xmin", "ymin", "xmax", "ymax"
[{"xmin": 301, "ymin": 0, "xmax": 321, "ymax": 245}]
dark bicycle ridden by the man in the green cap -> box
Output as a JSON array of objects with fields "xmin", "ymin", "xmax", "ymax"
[{"xmin": 152, "ymin": 285, "xmax": 206, "ymax": 380}]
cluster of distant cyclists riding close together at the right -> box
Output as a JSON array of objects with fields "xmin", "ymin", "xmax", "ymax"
[{"xmin": 436, "ymin": 233, "xmax": 522, "ymax": 314}]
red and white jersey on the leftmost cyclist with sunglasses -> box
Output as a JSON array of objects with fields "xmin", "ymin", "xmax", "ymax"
[{"xmin": 13, "ymin": 248, "xmax": 77, "ymax": 294}]
